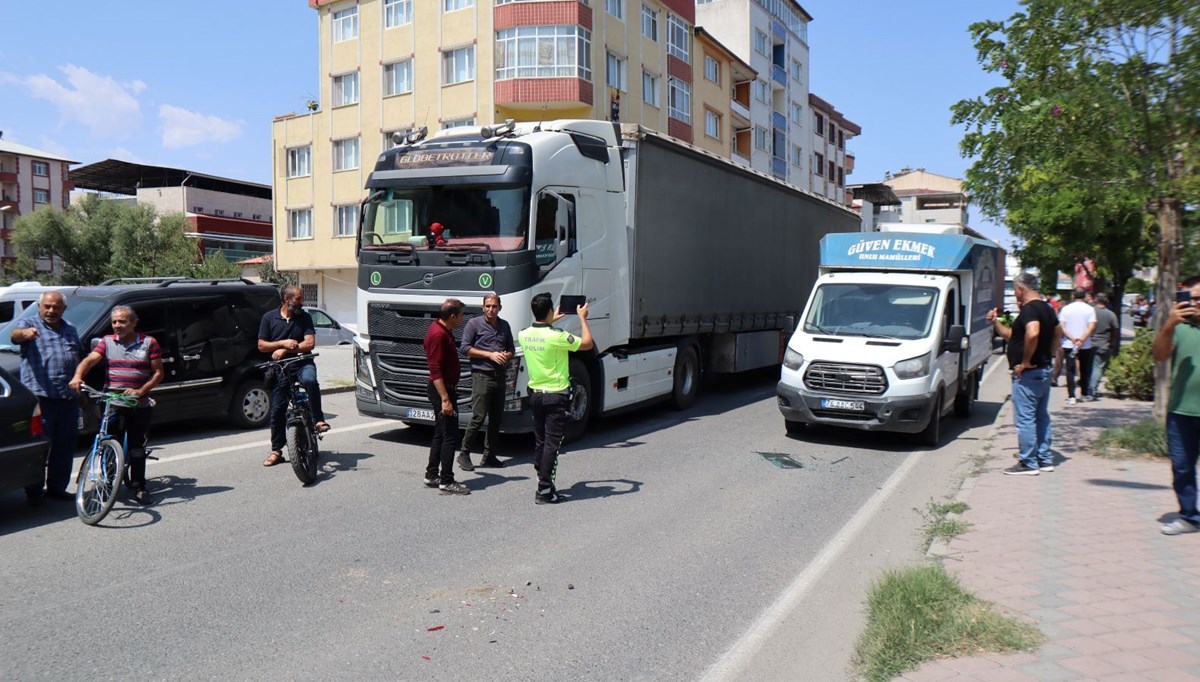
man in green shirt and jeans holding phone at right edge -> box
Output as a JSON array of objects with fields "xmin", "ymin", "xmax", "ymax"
[{"xmin": 1153, "ymin": 277, "xmax": 1200, "ymax": 536}]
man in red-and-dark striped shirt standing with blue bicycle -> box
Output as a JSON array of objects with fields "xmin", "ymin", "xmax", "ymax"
[{"xmin": 71, "ymin": 305, "xmax": 163, "ymax": 504}]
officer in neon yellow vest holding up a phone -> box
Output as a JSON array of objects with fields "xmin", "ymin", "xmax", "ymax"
[{"xmin": 517, "ymin": 292, "xmax": 592, "ymax": 504}]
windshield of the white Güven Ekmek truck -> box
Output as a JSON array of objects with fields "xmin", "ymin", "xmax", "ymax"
[{"xmin": 804, "ymin": 282, "xmax": 937, "ymax": 339}]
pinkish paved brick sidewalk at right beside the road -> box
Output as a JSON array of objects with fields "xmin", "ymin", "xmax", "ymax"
[{"xmin": 900, "ymin": 388, "xmax": 1200, "ymax": 682}]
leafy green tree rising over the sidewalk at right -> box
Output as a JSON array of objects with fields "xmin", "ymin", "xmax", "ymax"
[{"xmin": 953, "ymin": 0, "xmax": 1200, "ymax": 412}]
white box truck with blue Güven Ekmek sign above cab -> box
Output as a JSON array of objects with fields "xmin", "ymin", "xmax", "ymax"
[{"xmin": 778, "ymin": 223, "xmax": 1004, "ymax": 445}]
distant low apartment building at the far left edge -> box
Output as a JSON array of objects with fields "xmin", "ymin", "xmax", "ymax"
[{"xmin": 0, "ymin": 132, "xmax": 78, "ymax": 271}]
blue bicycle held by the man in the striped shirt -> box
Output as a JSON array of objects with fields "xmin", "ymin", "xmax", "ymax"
[{"xmin": 76, "ymin": 384, "xmax": 155, "ymax": 526}]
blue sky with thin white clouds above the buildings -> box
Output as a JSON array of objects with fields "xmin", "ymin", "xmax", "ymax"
[{"xmin": 0, "ymin": 0, "xmax": 1016, "ymax": 246}]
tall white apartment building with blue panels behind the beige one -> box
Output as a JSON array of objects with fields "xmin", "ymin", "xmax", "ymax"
[{"xmin": 696, "ymin": 0, "xmax": 812, "ymax": 190}]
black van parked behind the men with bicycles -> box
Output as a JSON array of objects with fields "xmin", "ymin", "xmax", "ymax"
[{"xmin": 0, "ymin": 277, "xmax": 281, "ymax": 429}]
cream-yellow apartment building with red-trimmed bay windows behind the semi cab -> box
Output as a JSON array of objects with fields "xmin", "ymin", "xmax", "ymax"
[{"xmin": 272, "ymin": 0, "xmax": 700, "ymax": 321}]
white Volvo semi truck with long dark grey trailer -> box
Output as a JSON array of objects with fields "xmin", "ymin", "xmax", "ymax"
[{"xmin": 355, "ymin": 120, "xmax": 859, "ymax": 437}]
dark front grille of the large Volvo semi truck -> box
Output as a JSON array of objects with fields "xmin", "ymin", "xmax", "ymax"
[{"xmin": 367, "ymin": 304, "xmax": 481, "ymax": 407}]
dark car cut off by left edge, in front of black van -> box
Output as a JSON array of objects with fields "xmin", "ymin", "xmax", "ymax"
[{"xmin": 0, "ymin": 362, "xmax": 50, "ymax": 501}]
